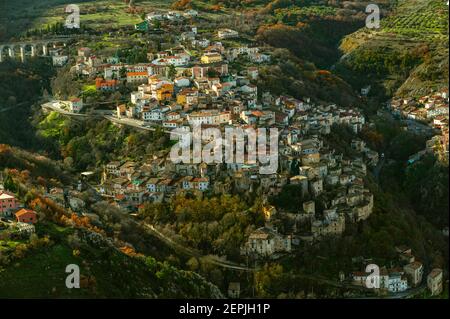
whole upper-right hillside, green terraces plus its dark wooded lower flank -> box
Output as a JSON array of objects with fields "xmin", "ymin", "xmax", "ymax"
[{"xmin": 336, "ymin": 0, "xmax": 448, "ymax": 96}]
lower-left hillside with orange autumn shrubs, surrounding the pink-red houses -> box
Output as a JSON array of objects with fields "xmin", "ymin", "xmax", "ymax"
[{"xmin": 0, "ymin": 148, "xmax": 223, "ymax": 298}]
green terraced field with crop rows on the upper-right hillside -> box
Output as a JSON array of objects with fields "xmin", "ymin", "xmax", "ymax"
[{"xmin": 340, "ymin": 0, "xmax": 448, "ymax": 96}]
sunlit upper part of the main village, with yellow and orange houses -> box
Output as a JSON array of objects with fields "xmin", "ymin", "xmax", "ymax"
[{"xmin": 74, "ymin": 14, "xmax": 270, "ymax": 128}]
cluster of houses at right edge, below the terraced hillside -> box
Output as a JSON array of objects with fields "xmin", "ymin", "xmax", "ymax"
[{"xmin": 389, "ymin": 89, "xmax": 449, "ymax": 163}]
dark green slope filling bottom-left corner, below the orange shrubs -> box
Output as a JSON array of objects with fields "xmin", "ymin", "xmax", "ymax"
[{"xmin": 0, "ymin": 223, "xmax": 223, "ymax": 298}]
